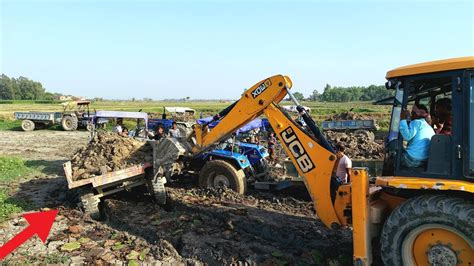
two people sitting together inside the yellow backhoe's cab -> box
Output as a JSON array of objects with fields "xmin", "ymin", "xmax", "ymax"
[{"xmin": 400, "ymin": 98, "xmax": 452, "ymax": 168}]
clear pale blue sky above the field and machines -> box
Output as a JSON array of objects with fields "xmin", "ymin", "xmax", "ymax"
[{"xmin": 0, "ymin": 0, "xmax": 474, "ymax": 100}]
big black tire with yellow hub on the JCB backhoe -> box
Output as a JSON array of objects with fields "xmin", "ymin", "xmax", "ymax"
[{"xmin": 380, "ymin": 195, "xmax": 474, "ymax": 265}]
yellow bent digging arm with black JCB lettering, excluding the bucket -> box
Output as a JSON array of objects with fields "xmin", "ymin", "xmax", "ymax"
[{"xmin": 193, "ymin": 75, "xmax": 341, "ymax": 227}]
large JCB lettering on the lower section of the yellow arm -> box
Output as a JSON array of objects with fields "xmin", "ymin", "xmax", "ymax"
[{"xmin": 280, "ymin": 127, "xmax": 314, "ymax": 173}]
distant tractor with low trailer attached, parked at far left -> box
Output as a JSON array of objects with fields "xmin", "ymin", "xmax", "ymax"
[{"xmin": 15, "ymin": 101, "xmax": 108, "ymax": 131}]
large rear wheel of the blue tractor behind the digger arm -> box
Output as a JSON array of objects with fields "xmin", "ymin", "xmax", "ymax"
[{"xmin": 199, "ymin": 160, "xmax": 247, "ymax": 194}]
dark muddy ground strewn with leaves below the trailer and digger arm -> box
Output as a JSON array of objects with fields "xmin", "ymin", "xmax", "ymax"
[{"xmin": 0, "ymin": 131, "xmax": 352, "ymax": 265}]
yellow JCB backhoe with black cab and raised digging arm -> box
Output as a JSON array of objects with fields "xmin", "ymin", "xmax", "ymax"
[{"xmin": 193, "ymin": 57, "xmax": 474, "ymax": 265}]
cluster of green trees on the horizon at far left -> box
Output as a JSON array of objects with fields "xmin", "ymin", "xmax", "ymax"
[{"xmin": 0, "ymin": 74, "xmax": 54, "ymax": 100}]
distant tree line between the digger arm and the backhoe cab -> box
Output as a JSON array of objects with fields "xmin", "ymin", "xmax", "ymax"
[{"xmin": 293, "ymin": 84, "xmax": 394, "ymax": 102}]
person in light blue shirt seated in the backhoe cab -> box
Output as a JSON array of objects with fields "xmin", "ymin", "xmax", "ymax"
[{"xmin": 400, "ymin": 104, "xmax": 435, "ymax": 167}]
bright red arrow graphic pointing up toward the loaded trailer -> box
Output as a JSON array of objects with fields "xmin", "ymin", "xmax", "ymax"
[{"xmin": 0, "ymin": 210, "xmax": 58, "ymax": 260}]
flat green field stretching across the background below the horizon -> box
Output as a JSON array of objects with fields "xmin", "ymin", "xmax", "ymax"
[{"xmin": 0, "ymin": 101, "xmax": 390, "ymax": 130}]
